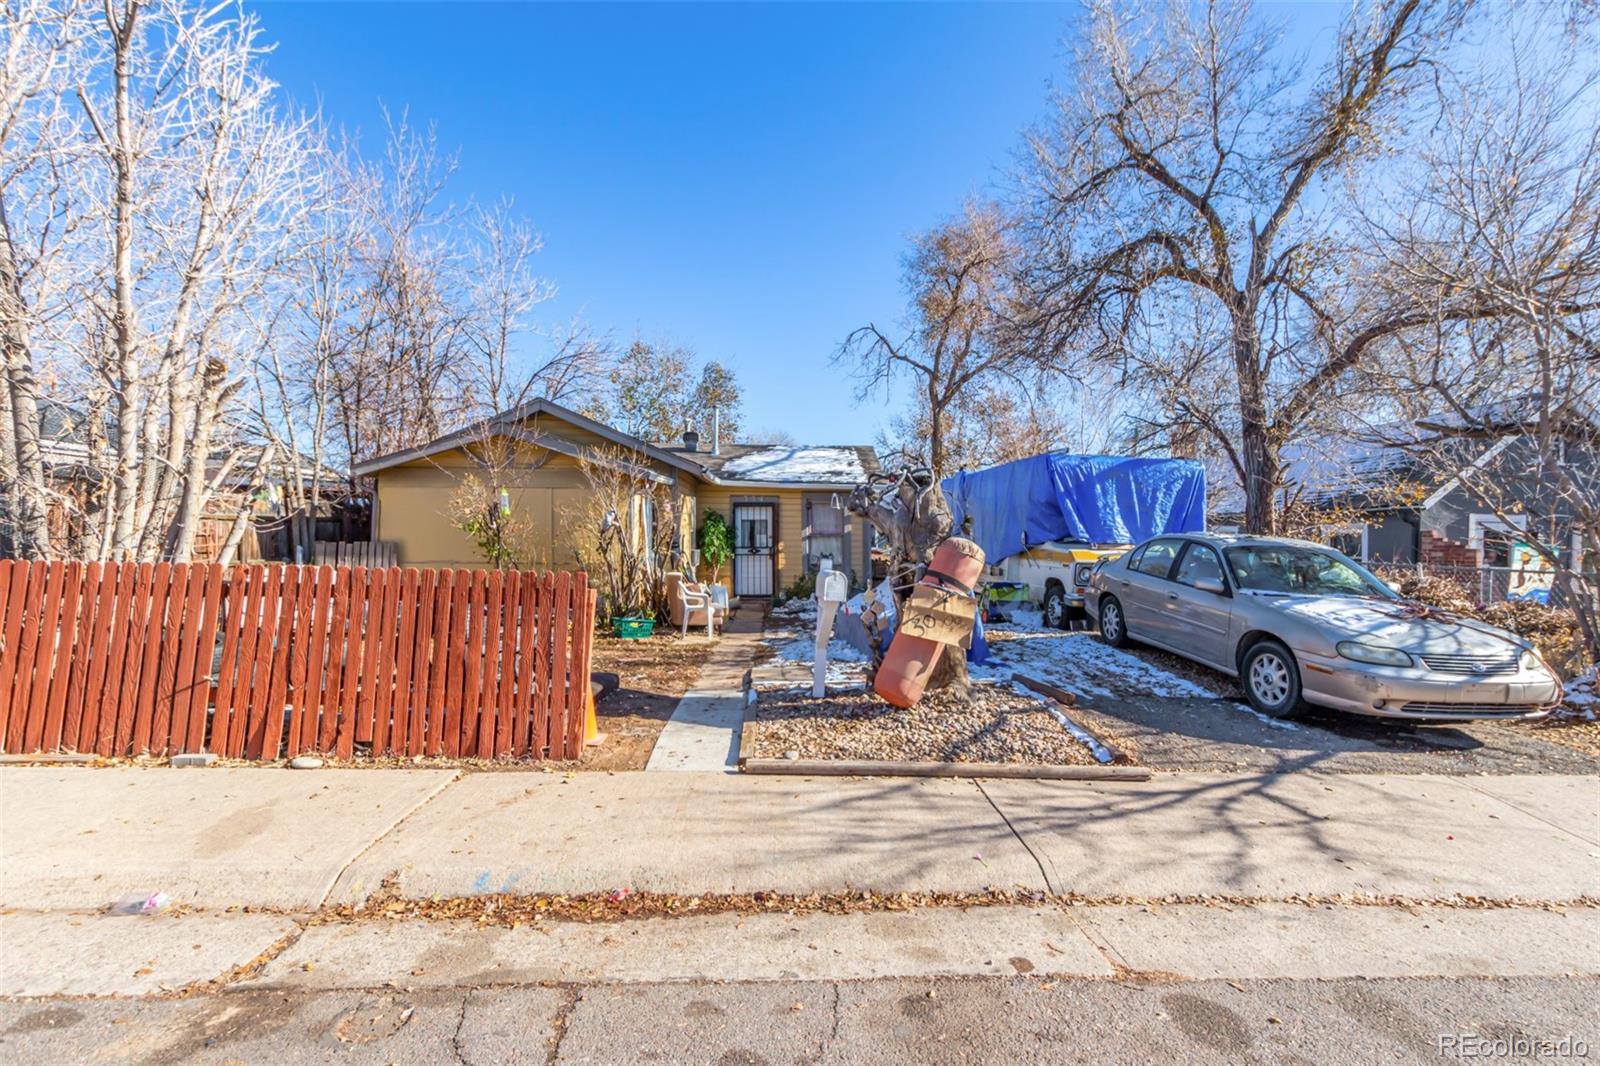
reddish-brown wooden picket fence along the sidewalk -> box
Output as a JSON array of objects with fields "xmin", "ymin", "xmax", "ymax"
[{"xmin": 0, "ymin": 560, "xmax": 595, "ymax": 759}]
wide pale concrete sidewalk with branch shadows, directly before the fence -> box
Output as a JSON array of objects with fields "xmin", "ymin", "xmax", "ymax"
[{"xmin": 0, "ymin": 768, "xmax": 1600, "ymax": 911}]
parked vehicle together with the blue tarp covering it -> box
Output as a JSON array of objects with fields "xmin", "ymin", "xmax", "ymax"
[{"xmin": 941, "ymin": 453, "xmax": 1205, "ymax": 629}]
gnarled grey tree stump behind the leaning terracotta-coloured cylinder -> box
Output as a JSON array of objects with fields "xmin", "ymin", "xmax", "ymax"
[{"xmin": 845, "ymin": 469, "xmax": 971, "ymax": 696}]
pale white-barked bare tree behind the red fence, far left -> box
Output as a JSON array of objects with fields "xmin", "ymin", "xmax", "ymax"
[{"xmin": 0, "ymin": 0, "xmax": 315, "ymax": 559}]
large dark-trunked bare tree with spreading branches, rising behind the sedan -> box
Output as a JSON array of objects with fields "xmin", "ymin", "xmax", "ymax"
[{"xmin": 1027, "ymin": 0, "xmax": 1461, "ymax": 533}]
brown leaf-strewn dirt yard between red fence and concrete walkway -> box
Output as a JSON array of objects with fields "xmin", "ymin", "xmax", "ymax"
[{"xmin": 576, "ymin": 629, "xmax": 712, "ymax": 770}]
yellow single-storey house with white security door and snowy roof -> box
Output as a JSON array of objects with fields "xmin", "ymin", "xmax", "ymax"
[{"xmin": 354, "ymin": 399, "xmax": 878, "ymax": 597}]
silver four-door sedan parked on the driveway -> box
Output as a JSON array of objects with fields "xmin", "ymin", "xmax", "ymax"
[{"xmin": 1090, "ymin": 533, "xmax": 1562, "ymax": 720}]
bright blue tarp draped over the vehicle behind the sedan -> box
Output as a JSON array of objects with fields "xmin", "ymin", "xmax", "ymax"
[{"xmin": 941, "ymin": 453, "xmax": 1205, "ymax": 563}]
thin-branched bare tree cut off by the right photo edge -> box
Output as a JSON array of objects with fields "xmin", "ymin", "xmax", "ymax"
[{"xmin": 1370, "ymin": 29, "xmax": 1600, "ymax": 661}]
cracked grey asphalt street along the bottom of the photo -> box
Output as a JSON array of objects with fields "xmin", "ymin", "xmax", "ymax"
[{"xmin": 0, "ymin": 976, "xmax": 1600, "ymax": 1066}]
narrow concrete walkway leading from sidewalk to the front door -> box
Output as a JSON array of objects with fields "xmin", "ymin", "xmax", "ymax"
[{"xmin": 645, "ymin": 605, "xmax": 762, "ymax": 773}]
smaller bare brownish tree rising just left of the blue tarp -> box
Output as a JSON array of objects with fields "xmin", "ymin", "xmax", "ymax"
[{"xmin": 835, "ymin": 203, "xmax": 1029, "ymax": 479}]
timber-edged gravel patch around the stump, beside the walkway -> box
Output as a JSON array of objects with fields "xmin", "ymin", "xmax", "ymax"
[{"xmin": 747, "ymin": 685, "xmax": 1096, "ymax": 767}]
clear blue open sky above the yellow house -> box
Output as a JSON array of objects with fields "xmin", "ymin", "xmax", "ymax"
[{"xmin": 256, "ymin": 2, "xmax": 1075, "ymax": 443}]
